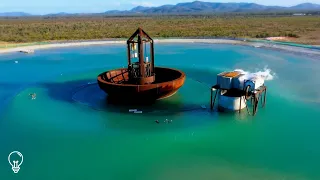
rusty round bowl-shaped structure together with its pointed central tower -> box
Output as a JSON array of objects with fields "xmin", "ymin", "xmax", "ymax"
[{"xmin": 97, "ymin": 28, "xmax": 186, "ymax": 102}]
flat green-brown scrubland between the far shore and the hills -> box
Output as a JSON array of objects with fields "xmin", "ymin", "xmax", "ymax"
[{"xmin": 0, "ymin": 16, "xmax": 320, "ymax": 44}]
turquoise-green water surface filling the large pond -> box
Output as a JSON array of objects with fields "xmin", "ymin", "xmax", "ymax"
[{"xmin": 0, "ymin": 44, "xmax": 320, "ymax": 180}]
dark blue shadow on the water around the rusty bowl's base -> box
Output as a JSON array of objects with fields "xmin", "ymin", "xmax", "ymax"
[{"xmin": 40, "ymin": 79, "xmax": 209, "ymax": 115}]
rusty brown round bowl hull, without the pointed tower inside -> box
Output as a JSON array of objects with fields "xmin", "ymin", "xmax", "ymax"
[{"xmin": 98, "ymin": 67, "xmax": 186, "ymax": 101}]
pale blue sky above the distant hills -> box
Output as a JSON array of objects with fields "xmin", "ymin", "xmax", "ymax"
[{"xmin": 0, "ymin": 0, "xmax": 320, "ymax": 15}]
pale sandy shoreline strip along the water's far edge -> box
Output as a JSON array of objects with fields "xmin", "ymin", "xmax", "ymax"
[{"xmin": 0, "ymin": 39, "xmax": 320, "ymax": 56}]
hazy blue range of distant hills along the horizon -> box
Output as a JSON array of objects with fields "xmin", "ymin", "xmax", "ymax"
[{"xmin": 0, "ymin": 1, "xmax": 320, "ymax": 17}]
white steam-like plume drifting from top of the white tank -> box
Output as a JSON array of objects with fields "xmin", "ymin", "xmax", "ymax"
[{"xmin": 234, "ymin": 67, "xmax": 276, "ymax": 81}]
